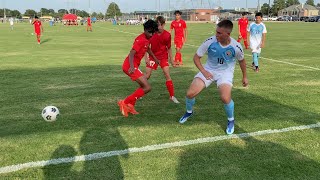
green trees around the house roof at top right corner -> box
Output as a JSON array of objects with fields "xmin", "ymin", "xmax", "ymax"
[{"xmin": 261, "ymin": 0, "xmax": 320, "ymax": 16}]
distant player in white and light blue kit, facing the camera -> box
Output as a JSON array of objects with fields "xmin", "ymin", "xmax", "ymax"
[{"xmin": 248, "ymin": 12, "xmax": 267, "ymax": 72}]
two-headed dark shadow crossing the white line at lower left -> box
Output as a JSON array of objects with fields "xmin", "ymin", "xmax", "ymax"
[{"xmin": 43, "ymin": 127, "xmax": 129, "ymax": 179}]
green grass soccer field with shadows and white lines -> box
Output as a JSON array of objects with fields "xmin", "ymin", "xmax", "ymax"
[{"xmin": 0, "ymin": 23, "xmax": 320, "ymax": 180}]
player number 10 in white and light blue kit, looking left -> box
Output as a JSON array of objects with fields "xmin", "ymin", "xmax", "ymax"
[{"xmin": 179, "ymin": 20, "xmax": 248, "ymax": 134}]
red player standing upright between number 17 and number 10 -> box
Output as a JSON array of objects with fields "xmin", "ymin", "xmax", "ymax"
[{"xmin": 170, "ymin": 11, "xmax": 187, "ymax": 65}]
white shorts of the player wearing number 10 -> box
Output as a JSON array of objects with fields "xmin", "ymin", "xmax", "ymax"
[{"xmin": 194, "ymin": 69, "xmax": 234, "ymax": 87}]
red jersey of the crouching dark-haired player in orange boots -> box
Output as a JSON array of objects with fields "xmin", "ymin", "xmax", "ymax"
[{"xmin": 124, "ymin": 33, "xmax": 150, "ymax": 67}]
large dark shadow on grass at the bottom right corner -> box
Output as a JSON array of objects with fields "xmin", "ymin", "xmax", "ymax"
[{"xmin": 176, "ymin": 127, "xmax": 320, "ymax": 180}]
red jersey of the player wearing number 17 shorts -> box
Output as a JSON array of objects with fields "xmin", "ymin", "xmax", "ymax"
[{"xmin": 150, "ymin": 30, "xmax": 171, "ymax": 60}]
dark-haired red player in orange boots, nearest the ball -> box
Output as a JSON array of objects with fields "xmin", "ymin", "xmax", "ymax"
[{"xmin": 118, "ymin": 20, "xmax": 159, "ymax": 117}]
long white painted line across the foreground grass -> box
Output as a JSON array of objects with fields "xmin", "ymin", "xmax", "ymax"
[{"xmin": 0, "ymin": 122, "xmax": 320, "ymax": 174}]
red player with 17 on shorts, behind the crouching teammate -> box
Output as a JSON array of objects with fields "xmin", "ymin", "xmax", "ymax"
[{"xmin": 146, "ymin": 16, "xmax": 179, "ymax": 103}]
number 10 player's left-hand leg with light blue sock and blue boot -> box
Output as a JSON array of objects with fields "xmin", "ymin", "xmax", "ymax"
[{"xmin": 179, "ymin": 75, "xmax": 211, "ymax": 124}]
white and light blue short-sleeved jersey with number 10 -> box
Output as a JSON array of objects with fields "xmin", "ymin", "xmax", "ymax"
[{"xmin": 197, "ymin": 36, "xmax": 244, "ymax": 71}]
